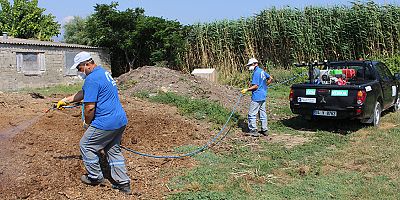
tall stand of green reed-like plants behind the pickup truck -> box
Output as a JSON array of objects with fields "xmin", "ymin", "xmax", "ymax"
[{"xmin": 183, "ymin": 1, "xmax": 400, "ymax": 83}]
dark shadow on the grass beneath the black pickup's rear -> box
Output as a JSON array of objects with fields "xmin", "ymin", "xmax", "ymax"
[{"xmin": 280, "ymin": 116, "xmax": 369, "ymax": 135}]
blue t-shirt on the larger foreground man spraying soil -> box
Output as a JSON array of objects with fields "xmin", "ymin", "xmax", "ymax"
[{"xmin": 82, "ymin": 66, "xmax": 128, "ymax": 130}]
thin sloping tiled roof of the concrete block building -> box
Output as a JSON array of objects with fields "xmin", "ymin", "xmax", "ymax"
[{"xmin": 0, "ymin": 36, "xmax": 98, "ymax": 49}]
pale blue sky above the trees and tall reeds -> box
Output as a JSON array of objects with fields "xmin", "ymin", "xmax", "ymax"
[{"xmin": 39, "ymin": 0, "xmax": 400, "ymax": 25}]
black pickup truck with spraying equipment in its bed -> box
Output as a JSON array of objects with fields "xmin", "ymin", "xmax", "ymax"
[{"xmin": 289, "ymin": 60, "xmax": 400, "ymax": 126}]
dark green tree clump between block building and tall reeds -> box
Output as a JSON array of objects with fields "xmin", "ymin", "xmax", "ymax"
[{"xmin": 85, "ymin": 2, "xmax": 185, "ymax": 76}]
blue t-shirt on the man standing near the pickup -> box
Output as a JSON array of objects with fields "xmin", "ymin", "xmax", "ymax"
[{"xmin": 251, "ymin": 67, "xmax": 271, "ymax": 101}]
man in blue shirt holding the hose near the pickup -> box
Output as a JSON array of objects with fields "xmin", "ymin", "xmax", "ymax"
[{"xmin": 241, "ymin": 58, "xmax": 272, "ymax": 137}]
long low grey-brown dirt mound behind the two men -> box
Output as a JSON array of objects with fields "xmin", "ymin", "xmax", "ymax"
[{"xmin": 118, "ymin": 66, "xmax": 249, "ymax": 115}]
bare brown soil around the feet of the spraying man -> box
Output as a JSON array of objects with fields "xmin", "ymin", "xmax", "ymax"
[{"xmin": 0, "ymin": 94, "xmax": 214, "ymax": 199}]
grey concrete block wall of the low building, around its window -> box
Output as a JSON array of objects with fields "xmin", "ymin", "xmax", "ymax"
[{"xmin": 0, "ymin": 44, "xmax": 111, "ymax": 91}]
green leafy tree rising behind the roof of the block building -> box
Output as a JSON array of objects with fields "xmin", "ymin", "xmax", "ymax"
[{"xmin": 0, "ymin": 0, "xmax": 61, "ymax": 40}]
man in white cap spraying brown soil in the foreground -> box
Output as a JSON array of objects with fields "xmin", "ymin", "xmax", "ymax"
[{"xmin": 57, "ymin": 52, "xmax": 131, "ymax": 194}]
